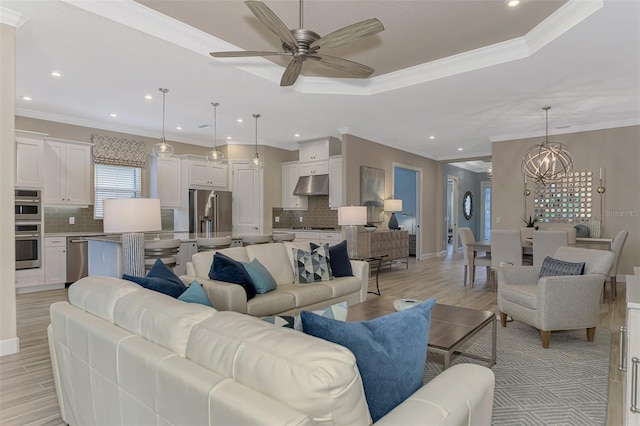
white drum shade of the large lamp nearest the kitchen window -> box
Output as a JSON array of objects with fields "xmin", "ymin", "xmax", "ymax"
[{"xmin": 103, "ymin": 198, "xmax": 162, "ymax": 233}]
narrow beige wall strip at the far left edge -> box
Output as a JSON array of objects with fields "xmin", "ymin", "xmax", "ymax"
[{"xmin": 0, "ymin": 24, "xmax": 18, "ymax": 355}]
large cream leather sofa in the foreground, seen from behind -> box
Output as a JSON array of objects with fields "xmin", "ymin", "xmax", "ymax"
[{"xmin": 48, "ymin": 276, "xmax": 494, "ymax": 426}]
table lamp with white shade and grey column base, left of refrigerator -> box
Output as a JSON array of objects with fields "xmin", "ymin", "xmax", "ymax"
[{"xmin": 103, "ymin": 198, "xmax": 162, "ymax": 277}]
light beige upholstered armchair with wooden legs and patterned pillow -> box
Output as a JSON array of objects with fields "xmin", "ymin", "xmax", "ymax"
[{"xmin": 498, "ymin": 247, "xmax": 614, "ymax": 348}]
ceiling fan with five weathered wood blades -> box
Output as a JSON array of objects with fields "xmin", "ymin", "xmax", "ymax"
[{"xmin": 210, "ymin": 0, "xmax": 384, "ymax": 86}]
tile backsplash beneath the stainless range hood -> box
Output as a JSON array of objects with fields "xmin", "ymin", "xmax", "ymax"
[{"xmin": 272, "ymin": 195, "xmax": 339, "ymax": 229}]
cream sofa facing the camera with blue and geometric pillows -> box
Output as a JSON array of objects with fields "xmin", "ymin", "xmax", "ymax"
[{"xmin": 180, "ymin": 242, "xmax": 369, "ymax": 316}]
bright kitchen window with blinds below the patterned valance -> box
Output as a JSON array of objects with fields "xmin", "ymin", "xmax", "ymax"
[{"xmin": 93, "ymin": 164, "xmax": 142, "ymax": 219}]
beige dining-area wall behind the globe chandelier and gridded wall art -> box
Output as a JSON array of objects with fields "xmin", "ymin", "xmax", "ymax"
[{"xmin": 492, "ymin": 126, "xmax": 640, "ymax": 274}]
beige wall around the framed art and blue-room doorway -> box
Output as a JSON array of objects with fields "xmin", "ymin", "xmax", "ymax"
[{"xmin": 342, "ymin": 135, "xmax": 441, "ymax": 257}]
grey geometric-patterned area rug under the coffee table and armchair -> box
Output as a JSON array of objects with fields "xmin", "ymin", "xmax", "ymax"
[{"xmin": 425, "ymin": 321, "xmax": 611, "ymax": 426}]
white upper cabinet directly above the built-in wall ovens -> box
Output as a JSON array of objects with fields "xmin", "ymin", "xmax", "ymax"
[{"xmin": 15, "ymin": 130, "xmax": 47, "ymax": 188}]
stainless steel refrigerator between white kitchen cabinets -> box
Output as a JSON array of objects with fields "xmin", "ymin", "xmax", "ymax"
[{"xmin": 189, "ymin": 189, "xmax": 231, "ymax": 234}]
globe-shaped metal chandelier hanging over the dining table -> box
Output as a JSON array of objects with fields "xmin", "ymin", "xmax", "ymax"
[{"xmin": 521, "ymin": 107, "xmax": 573, "ymax": 185}]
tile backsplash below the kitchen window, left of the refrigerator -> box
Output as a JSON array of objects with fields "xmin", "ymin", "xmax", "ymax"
[{"xmin": 44, "ymin": 206, "xmax": 173, "ymax": 234}]
